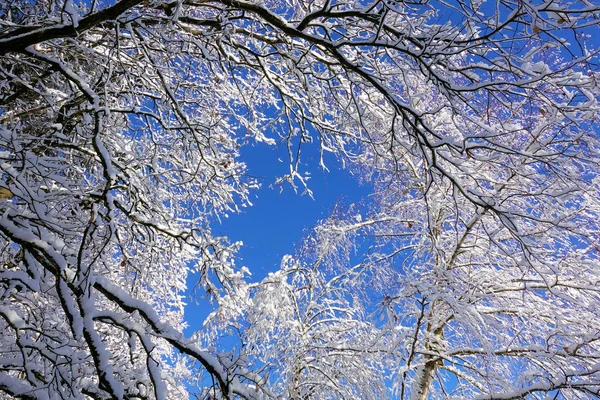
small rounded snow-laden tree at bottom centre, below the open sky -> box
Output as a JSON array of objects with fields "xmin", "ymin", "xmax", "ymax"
[{"xmin": 242, "ymin": 248, "xmax": 394, "ymax": 399}]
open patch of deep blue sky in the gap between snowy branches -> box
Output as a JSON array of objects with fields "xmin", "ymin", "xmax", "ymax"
[{"xmin": 186, "ymin": 139, "xmax": 370, "ymax": 335}]
